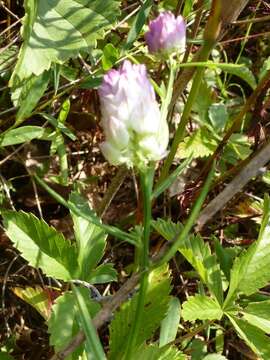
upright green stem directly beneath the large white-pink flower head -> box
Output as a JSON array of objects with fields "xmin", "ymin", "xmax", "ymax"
[{"xmin": 124, "ymin": 168, "xmax": 154, "ymax": 360}]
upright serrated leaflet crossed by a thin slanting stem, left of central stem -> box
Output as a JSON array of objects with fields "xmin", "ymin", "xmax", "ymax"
[{"xmin": 70, "ymin": 192, "xmax": 107, "ymax": 281}]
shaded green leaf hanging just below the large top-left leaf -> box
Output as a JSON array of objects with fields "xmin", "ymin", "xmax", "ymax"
[{"xmin": 10, "ymin": 71, "xmax": 50, "ymax": 123}]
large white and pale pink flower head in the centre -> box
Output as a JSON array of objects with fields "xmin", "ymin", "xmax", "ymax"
[{"xmin": 98, "ymin": 60, "xmax": 169, "ymax": 167}]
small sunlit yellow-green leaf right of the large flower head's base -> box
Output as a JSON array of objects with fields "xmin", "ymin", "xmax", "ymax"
[{"xmin": 176, "ymin": 128, "xmax": 217, "ymax": 159}]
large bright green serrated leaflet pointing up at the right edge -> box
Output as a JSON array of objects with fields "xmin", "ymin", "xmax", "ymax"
[{"xmin": 226, "ymin": 195, "xmax": 270, "ymax": 304}]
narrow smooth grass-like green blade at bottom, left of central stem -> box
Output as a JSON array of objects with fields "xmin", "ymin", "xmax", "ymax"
[{"xmin": 73, "ymin": 287, "xmax": 106, "ymax": 360}]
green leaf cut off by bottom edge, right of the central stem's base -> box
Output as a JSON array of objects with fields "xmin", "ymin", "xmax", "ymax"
[{"xmin": 130, "ymin": 345, "xmax": 187, "ymax": 360}]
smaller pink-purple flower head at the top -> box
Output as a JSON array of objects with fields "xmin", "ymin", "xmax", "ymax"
[{"xmin": 145, "ymin": 11, "xmax": 186, "ymax": 55}]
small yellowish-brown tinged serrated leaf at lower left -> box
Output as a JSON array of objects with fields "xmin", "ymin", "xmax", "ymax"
[{"xmin": 12, "ymin": 286, "xmax": 60, "ymax": 319}]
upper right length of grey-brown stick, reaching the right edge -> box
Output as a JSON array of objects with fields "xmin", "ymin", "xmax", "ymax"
[{"xmin": 196, "ymin": 141, "xmax": 270, "ymax": 231}]
